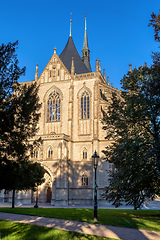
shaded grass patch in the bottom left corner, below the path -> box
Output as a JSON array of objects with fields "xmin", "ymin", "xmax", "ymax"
[{"xmin": 0, "ymin": 220, "xmax": 117, "ymax": 240}]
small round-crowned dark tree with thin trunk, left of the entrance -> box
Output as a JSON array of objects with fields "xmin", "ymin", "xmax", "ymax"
[{"xmin": 0, "ymin": 160, "xmax": 44, "ymax": 208}]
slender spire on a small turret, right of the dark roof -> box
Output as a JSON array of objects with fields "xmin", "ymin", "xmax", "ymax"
[{"xmin": 82, "ymin": 14, "xmax": 92, "ymax": 72}]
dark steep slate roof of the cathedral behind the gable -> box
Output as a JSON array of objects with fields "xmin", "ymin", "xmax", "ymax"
[{"xmin": 59, "ymin": 36, "xmax": 90, "ymax": 74}]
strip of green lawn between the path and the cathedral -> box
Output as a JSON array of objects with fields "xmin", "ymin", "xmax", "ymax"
[{"xmin": 0, "ymin": 208, "xmax": 160, "ymax": 231}]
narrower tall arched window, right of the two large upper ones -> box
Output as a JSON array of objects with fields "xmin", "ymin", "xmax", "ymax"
[{"xmin": 81, "ymin": 91, "xmax": 90, "ymax": 119}]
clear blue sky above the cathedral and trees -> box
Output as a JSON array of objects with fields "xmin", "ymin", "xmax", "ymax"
[{"xmin": 0, "ymin": 0, "xmax": 160, "ymax": 89}]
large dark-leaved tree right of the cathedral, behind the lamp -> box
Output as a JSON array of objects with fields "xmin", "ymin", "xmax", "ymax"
[{"xmin": 103, "ymin": 64, "xmax": 160, "ymax": 209}]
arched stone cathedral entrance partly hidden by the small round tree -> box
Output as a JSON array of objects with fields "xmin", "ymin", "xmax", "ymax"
[{"xmin": 31, "ymin": 171, "xmax": 52, "ymax": 203}]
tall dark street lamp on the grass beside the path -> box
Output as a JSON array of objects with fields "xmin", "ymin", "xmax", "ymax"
[{"xmin": 92, "ymin": 151, "xmax": 99, "ymax": 222}]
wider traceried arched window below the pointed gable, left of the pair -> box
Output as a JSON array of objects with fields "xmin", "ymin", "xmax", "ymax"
[{"xmin": 47, "ymin": 91, "xmax": 61, "ymax": 122}]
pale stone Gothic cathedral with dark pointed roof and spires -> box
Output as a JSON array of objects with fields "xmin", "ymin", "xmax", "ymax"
[{"xmin": 0, "ymin": 19, "xmax": 118, "ymax": 206}]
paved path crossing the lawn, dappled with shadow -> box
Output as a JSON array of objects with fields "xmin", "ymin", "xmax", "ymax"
[{"xmin": 0, "ymin": 212, "xmax": 160, "ymax": 240}]
